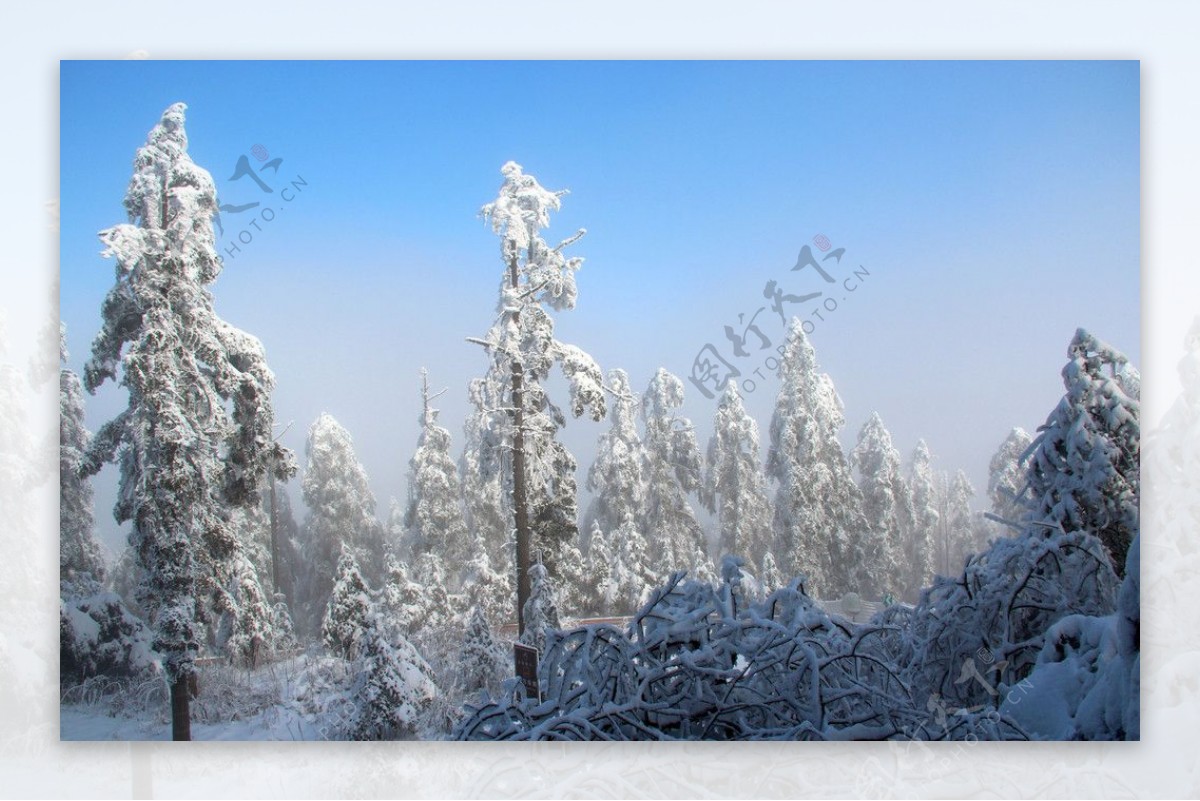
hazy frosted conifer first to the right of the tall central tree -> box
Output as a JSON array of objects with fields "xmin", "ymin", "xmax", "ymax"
[{"xmin": 584, "ymin": 369, "xmax": 646, "ymax": 547}]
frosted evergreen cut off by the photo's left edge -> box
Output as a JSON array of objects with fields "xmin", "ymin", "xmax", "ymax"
[{"xmin": 59, "ymin": 328, "xmax": 106, "ymax": 589}]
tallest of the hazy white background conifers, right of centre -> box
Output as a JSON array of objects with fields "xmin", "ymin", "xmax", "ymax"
[{"xmin": 767, "ymin": 318, "xmax": 866, "ymax": 597}]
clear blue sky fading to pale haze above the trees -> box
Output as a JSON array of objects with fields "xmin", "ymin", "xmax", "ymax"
[{"xmin": 61, "ymin": 61, "xmax": 1141, "ymax": 556}]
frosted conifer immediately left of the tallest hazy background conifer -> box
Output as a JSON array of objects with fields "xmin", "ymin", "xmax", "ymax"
[{"xmin": 701, "ymin": 381, "xmax": 772, "ymax": 568}]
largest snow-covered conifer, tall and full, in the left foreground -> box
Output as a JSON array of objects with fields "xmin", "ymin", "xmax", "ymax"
[{"xmin": 83, "ymin": 103, "xmax": 294, "ymax": 740}]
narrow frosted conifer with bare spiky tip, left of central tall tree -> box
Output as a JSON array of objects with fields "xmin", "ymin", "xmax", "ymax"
[{"xmin": 404, "ymin": 369, "xmax": 472, "ymax": 577}]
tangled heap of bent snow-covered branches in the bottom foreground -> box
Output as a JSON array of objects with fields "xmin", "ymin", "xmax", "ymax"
[{"xmin": 455, "ymin": 560, "xmax": 1021, "ymax": 740}]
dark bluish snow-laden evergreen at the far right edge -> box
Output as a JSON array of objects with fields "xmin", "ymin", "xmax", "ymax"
[{"xmin": 1025, "ymin": 329, "xmax": 1141, "ymax": 574}]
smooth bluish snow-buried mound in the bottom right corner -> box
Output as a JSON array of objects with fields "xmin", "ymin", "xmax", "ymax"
[{"xmin": 1001, "ymin": 536, "xmax": 1141, "ymax": 740}]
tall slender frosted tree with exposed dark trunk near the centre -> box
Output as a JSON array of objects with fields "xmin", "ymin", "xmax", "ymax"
[{"xmin": 465, "ymin": 162, "xmax": 606, "ymax": 630}]
